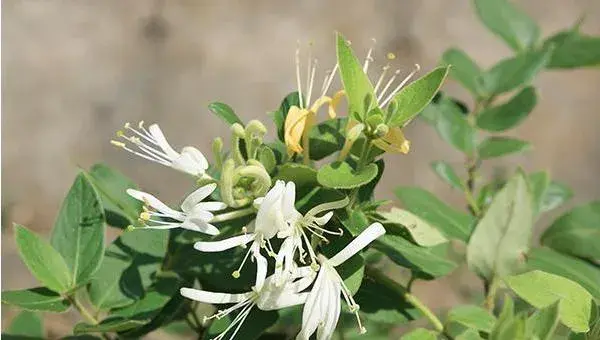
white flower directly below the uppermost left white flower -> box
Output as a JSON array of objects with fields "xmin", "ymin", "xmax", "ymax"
[{"xmin": 127, "ymin": 184, "xmax": 227, "ymax": 235}]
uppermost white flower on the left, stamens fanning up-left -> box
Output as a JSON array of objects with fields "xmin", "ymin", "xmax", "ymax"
[{"xmin": 110, "ymin": 121, "xmax": 208, "ymax": 177}]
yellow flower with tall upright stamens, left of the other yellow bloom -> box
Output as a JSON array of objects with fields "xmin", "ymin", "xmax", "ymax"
[{"xmin": 284, "ymin": 43, "xmax": 344, "ymax": 155}]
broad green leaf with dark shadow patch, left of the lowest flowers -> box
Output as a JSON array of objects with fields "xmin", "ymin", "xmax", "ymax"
[{"xmin": 88, "ymin": 229, "xmax": 168, "ymax": 309}]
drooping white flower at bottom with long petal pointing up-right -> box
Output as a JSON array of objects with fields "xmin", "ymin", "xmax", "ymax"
[{"xmin": 296, "ymin": 223, "xmax": 385, "ymax": 340}]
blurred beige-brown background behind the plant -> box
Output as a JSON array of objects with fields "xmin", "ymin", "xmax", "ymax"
[{"xmin": 1, "ymin": 0, "xmax": 600, "ymax": 334}]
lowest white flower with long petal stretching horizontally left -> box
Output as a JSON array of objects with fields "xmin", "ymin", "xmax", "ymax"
[{"xmin": 180, "ymin": 267, "xmax": 314, "ymax": 340}]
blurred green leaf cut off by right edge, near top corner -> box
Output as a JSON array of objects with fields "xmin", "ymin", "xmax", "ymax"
[{"xmin": 544, "ymin": 30, "xmax": 600, "ymax": 69}]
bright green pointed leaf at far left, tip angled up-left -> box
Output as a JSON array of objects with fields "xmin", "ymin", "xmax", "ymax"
[{"xmin": 15, "ymin": 224, "xmax": 72, "ymax": 293}]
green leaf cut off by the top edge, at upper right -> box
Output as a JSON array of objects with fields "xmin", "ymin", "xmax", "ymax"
[{"xmin": 475, "ymin": 0, "xmax": 540, "ymax": 51}]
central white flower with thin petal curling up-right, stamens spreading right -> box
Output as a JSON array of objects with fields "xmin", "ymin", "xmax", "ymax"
[{"xmin": 274, "ymin": 197, "xmax": 349, "ymax": 282}]
